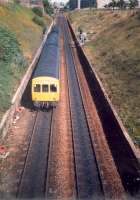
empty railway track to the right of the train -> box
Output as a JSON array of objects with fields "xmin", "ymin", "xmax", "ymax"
[{"xmin": 63, "ymin": 16, "xmax": 103, "ymax": 199}]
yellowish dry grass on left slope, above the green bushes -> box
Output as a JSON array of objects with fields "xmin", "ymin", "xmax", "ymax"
[{"xmin": 0, "ymin": 4, "xmax": 50, "ymax": 59}]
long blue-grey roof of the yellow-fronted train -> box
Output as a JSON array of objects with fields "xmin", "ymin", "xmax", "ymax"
[{"xmin": 33, "ymin": 26, "xmax": 60, "ymax": 79}]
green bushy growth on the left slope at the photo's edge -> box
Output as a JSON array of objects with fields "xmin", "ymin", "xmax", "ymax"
[{"xmin": 0, "ymin": 25, "xmax": 27, "ymax": 111}]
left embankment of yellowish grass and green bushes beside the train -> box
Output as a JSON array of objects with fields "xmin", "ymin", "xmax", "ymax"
[{"xmin": 0, "ymin": 4, "xmax": 51, "ymax": 119}]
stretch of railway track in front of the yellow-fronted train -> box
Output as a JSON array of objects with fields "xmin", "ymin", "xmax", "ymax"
[{"xmin": 17, "ymin": 110, "xmax": 54, "ymax": 198}]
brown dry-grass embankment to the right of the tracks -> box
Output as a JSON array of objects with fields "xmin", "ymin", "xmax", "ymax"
[{"xmin": 69, "ymin": 10, "xmax": 140, "ymax": 146}]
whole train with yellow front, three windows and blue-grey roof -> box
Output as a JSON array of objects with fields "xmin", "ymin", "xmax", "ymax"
[{"xmin": 31, "ymin": 25, "xmax": 60, "ymax": 107}]
